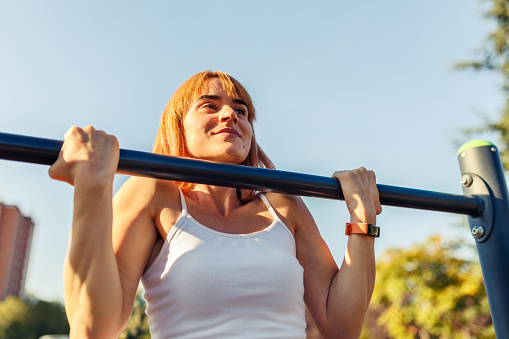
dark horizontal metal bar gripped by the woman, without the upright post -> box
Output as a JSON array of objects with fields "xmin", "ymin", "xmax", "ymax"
[{"xmin": 0, "ymin": 133, "xmax": 484, "ymax": 216}]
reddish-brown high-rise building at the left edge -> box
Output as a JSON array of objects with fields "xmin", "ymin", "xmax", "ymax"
[{"xmin": 0, "ymin": 203, "xmax": 34, "ymax": 300}]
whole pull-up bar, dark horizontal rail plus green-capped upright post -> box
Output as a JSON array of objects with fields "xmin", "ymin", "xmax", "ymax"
[{"xmin": 0, "ymin": 133, "xmax": 509, "ymax": 339}]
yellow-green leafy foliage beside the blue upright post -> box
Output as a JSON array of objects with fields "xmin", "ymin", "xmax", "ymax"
[{"xmin": 363, "ymin": 237, "xmax": 495, "ymax": 339}]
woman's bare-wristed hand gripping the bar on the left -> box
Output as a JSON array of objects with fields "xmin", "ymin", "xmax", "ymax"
[{"xmin": 48, "ymin": 126, "xmax": 120, "ymax": 186}]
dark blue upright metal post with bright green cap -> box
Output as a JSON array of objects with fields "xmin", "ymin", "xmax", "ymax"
[{"xmin": 458, "ymin": 140, "xmax": 509, "ymax": 338}]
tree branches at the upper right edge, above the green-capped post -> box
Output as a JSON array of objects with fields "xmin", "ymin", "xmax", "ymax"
[{"xmin": 456, "ymin": 0, "xmax": 509, "ymax": 168}]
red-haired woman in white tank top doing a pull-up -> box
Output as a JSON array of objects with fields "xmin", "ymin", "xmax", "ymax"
[{"xmin": 49, "ymin": 71, "xmax": 381, "ymax": 338}]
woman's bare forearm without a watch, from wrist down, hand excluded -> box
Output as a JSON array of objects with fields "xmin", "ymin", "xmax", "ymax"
[{"xmin": 64, "ymin": 178, "xmax": 123, "ymax": 338}]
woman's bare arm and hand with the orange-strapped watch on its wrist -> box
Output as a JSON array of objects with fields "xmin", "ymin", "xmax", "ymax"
[{"xmin": 293, "ymin": 168, "xmax": 381, "ymax": 338}]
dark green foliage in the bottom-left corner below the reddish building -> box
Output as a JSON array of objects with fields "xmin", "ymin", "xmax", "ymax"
[{"xmin": 0, "ymin": 296, "xmax": 69, "ymax": 339}]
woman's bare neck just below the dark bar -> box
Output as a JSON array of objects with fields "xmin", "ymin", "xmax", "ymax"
[{"xmin": 184, "ymin": 184, "xmax": 243, "ymax": 215}]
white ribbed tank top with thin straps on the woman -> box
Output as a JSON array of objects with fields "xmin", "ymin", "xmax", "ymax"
[{"xmin": 142, "ymin": 192, "xmax": 306, "ymax": 339}]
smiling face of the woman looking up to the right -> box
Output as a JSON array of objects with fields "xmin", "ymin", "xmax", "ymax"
[{"xmin": 183, "ymin": 78, "xmax": 253, "ymax": 164}]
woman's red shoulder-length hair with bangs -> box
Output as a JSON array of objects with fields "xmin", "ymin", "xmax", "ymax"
[{"xmin": 152, "ymin": 71, "xmax": 275, "ymax": 203}]
